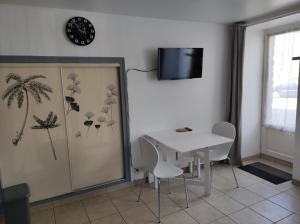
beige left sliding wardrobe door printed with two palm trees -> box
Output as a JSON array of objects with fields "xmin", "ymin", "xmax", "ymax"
[{"xmin": 0, "ymin": 63, "xmax": 71, "ymax": 201}]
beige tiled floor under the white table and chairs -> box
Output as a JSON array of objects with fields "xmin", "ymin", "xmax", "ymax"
[{"xmin": 2, "ymin": 158, "xmax": 300, "ymax": 224}]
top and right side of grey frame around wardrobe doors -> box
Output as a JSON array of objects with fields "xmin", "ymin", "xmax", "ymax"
[{"xmin": 0, "ymin": 55, "xmax": 131, "ymax": 194}]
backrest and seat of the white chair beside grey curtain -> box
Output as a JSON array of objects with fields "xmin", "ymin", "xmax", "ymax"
[{"xmin": 212, "ymin": 121, "xmax": 236, "ymax": 156}]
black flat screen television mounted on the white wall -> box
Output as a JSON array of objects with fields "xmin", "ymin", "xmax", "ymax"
[{"xmin": 158, "ymin": 48, "xmax": 203, "ymax": 80}]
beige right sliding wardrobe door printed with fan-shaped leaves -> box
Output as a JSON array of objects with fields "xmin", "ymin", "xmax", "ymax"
[{"xmin": 61, "ymin": 65, "xmax": 124, "ymax": 190}]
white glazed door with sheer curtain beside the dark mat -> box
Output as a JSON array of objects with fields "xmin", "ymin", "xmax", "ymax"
[{"xmin": 261, "ymin": 30, "xmax": 300, "ymax": 162}]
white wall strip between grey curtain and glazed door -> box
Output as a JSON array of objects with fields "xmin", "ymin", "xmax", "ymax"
[{"xmin": 241, "ymin": 27, "xmax": 264, "ymax": 158}]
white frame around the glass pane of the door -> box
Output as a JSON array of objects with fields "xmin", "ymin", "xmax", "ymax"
[{"xmin": 261, "ymin": 22, "xmax": 300, "ymax": 133}]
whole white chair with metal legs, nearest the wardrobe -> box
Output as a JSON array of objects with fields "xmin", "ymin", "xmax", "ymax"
[{"xmin": 137, "ymin": 136, "xmax": 189, "ymax": 223}]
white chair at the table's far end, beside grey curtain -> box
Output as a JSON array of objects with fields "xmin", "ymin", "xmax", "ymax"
[{"xmin": 196, "ymin": 121, "xmax": 239, "ymax": 188}]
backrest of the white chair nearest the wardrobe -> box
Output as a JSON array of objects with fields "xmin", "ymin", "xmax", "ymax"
[{"xmin": 139, "ymin": 136, "xmax": 159, "ymax": 174}]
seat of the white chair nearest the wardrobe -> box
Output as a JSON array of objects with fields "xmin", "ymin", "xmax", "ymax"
[{"xmin": 154, "ymin": 162, "xmax": 183, "ymax": 178}]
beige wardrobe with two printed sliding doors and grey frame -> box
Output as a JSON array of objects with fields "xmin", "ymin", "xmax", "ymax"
[{"xmin": 0, "ymin": 56, "xmax": 130, "ymax": 202}]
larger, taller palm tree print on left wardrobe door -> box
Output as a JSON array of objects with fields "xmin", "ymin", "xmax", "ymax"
[{"xmin": 2, "ymin": 73, "xmax": 52, "ymax": 146}]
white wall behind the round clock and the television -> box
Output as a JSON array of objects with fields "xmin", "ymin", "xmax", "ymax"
[{"xmin": 0, "ymin": 5, "xmax": 229, "ymax": 199}]
